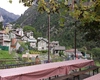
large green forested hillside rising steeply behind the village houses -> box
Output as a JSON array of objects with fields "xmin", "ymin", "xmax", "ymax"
[{"xmin": 16, "ymin": 6, "xmax": 99, "ymax": 49}]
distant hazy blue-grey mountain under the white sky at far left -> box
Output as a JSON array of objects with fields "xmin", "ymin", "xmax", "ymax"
[{"xmin": 0, "ymin": 8, "xmax": 20, "ymax": 23}]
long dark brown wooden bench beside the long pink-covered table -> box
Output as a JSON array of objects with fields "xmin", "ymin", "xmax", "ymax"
[{"xmin": 50, "ymin": 66, "xmax": 100, "ymax": 80}]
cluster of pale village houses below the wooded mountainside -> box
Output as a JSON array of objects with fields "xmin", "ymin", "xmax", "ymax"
[{"xmin": 0, "ymin": 13, "xmax": 82, "ymax": 60}]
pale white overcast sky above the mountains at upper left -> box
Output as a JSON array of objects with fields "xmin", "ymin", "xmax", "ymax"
[{"xmin": 0, "ymin": 0, "xmax": 27, "ymax": 15}]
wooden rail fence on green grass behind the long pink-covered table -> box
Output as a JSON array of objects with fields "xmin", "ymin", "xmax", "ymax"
[{"xmin": 0, "ymin": 58, "xmax": 34, "ymax": 69}]
